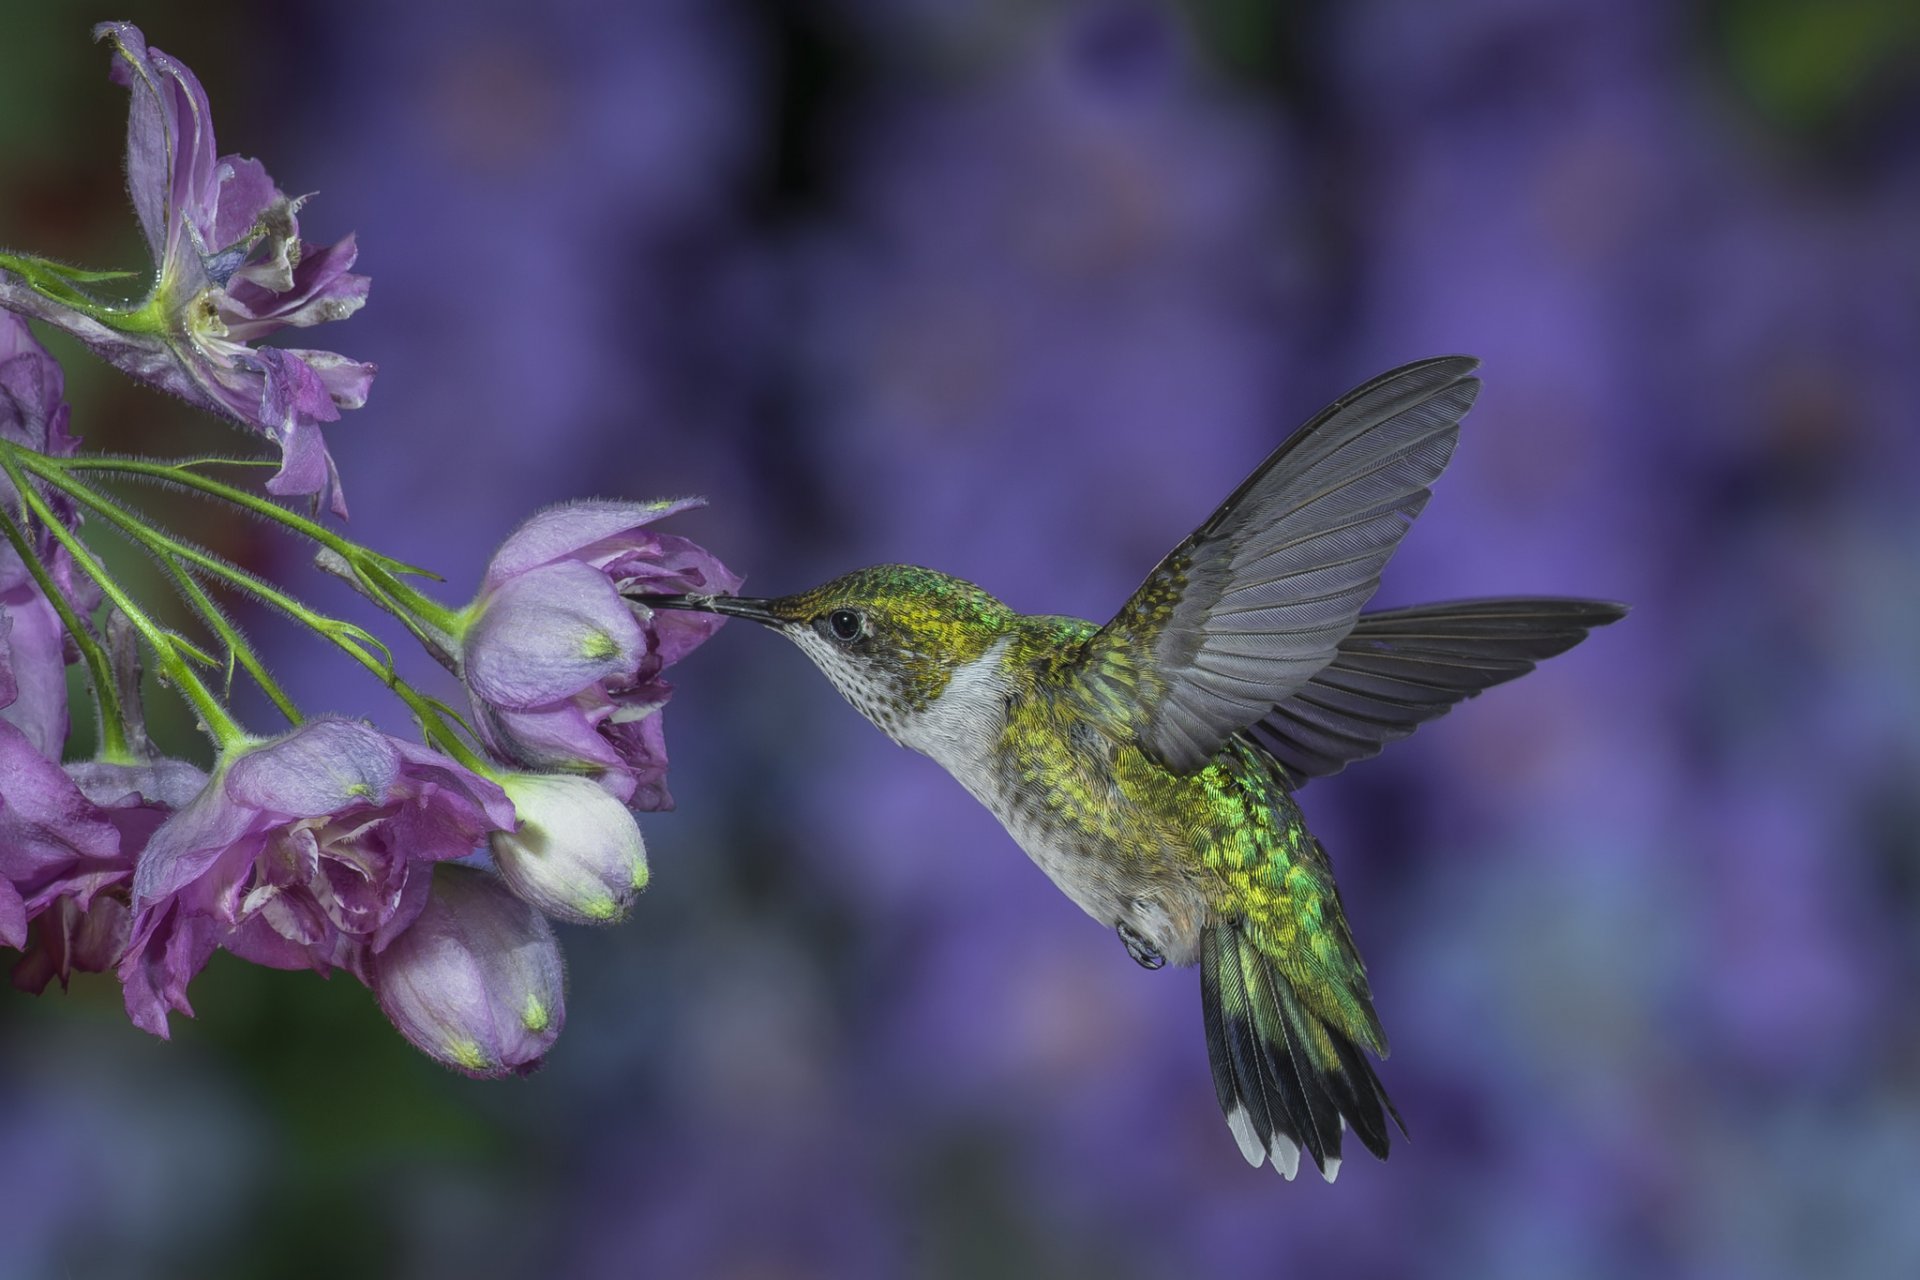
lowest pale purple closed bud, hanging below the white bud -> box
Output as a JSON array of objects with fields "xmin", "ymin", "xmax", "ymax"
[{"xmin": 371, "ymin": 865, "xmax": 566, "ymax": 1079}]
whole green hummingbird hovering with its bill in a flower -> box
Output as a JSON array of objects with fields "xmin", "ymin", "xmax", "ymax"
[{"xmin": 634, "ymin": 357, "xmax": 1626, "ymax": 1182}]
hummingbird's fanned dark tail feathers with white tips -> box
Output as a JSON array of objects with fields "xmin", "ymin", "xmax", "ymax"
[{"xmin": 1200, "ymin": 925, "xmax": 1407, "ymax": 1182}]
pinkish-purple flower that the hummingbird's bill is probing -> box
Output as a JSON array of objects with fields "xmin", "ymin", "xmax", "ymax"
[{"xmin": 461, "ymin": 499, "xmax": 739, "ymax": 810}]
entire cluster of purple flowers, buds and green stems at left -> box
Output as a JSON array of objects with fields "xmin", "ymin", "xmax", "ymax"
[{"xmin": 0, "ymin": 23, "xmax": 739, "ymax": 1077}]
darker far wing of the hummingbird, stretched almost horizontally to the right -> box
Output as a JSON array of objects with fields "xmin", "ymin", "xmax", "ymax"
[{"xmin": 1252, "ymin": 599, "xmax": 1626, "ymax": 787}]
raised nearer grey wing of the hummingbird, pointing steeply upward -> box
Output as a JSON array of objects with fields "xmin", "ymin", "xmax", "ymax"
[{"xmin": 1079, "ymin": 355, "xmax": 1480, "ymax": 773}]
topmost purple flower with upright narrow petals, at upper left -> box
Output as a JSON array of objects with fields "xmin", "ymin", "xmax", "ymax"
[{"xmin": 0, "ymin": 23, "xmax": 374, "ymax": 514}]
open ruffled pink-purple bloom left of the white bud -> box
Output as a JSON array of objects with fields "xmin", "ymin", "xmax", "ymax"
[{"xmin": 119, "ymin": 720, "xmax": 515, "ymax": 1036}]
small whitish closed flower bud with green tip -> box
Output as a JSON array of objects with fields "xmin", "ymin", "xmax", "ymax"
[{"xmin": 490, "ymin": 773, "xmax": 647, "ymax": 925}]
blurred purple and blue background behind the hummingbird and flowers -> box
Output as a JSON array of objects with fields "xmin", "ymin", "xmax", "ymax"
[{"xmin": 0, "ymin": 0, "xmax": 1920, "ymax": 1280}]
